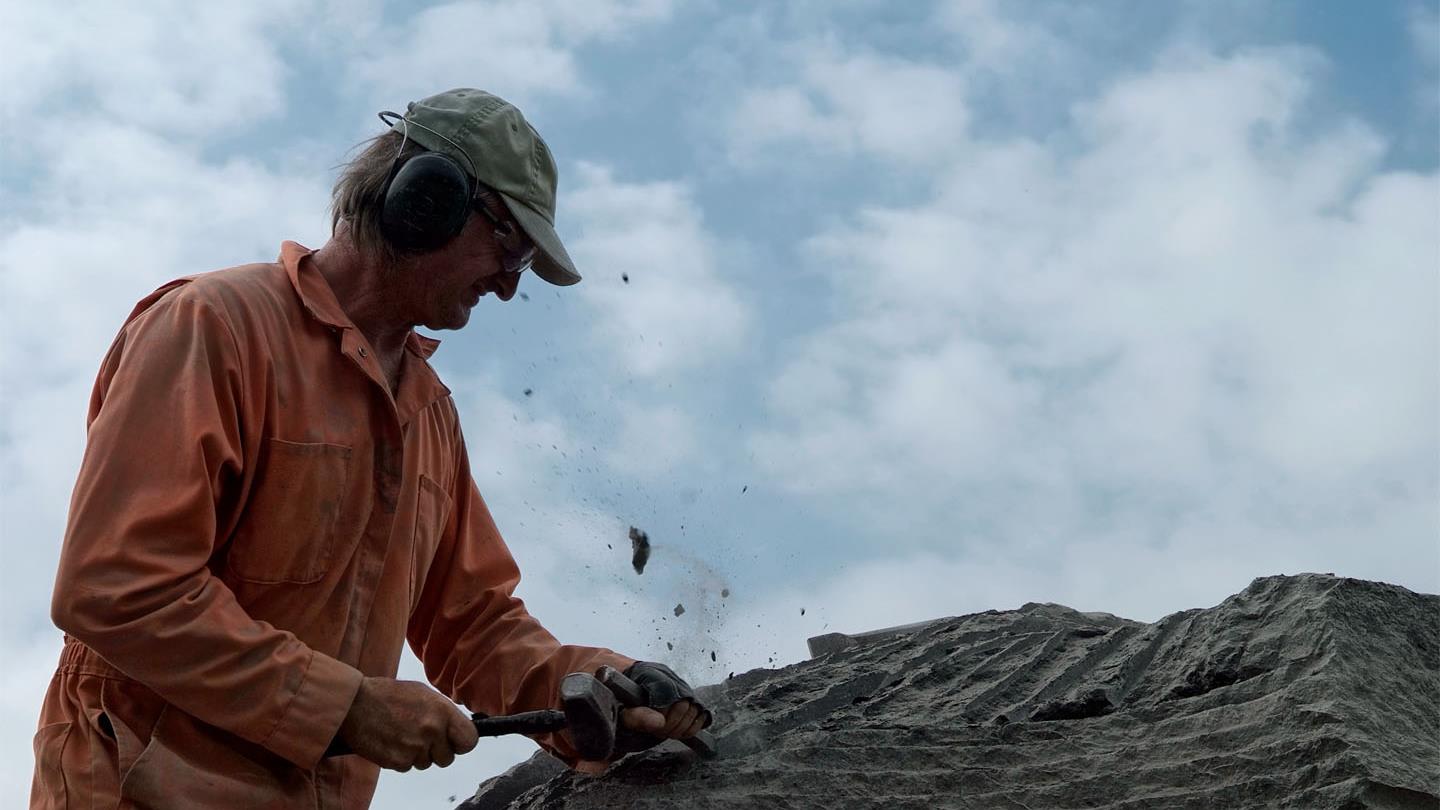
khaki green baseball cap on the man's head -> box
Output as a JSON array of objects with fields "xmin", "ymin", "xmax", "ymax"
[{"xmin": 390, "ymin": 88, "xmax": 580, "ymax": 287}]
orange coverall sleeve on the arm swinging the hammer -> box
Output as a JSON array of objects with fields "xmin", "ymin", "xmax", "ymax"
[{"xmin": 50, "ymin": 288, "xmax": 361, "ymax": 768}]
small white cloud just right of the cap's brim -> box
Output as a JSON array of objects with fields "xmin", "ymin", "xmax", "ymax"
[{"xmin": 560, "ymin": 163, "xmax": 752, "ymax": 378}]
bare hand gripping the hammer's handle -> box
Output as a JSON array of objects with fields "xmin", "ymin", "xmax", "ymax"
[{"xmin": 338, "ymin": 677, "xmax": 480, "ymax": 773}]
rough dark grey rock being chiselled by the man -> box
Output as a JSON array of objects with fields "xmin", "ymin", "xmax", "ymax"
[{"xmin": 467, "ymin": 574, "xmax": 1440, "ymax": 810}]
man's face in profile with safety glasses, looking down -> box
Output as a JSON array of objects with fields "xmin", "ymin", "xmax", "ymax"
[{"xmin": 410, "ymin": 202, "xmax": 523, "ymax": 329}]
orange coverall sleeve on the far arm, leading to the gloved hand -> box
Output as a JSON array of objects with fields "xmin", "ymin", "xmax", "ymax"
[{"xmin": 409, "ymin": 429, "xmax": 634, "ymax": 765}]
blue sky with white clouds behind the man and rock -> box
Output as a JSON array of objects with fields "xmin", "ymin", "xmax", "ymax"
[{"xmin": 0, "ymin": 0, "xmax": 1440, "ymax": 809}]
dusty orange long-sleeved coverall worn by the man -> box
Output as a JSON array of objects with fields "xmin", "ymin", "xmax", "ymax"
[{"xmin": 30, "ymin": 242, "xmax": 632, "ymax": 810}]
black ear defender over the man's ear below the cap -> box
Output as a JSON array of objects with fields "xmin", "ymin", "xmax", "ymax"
[{"xmin": 380, "ymin": 112, "xmax": 475, "ymax": 254}]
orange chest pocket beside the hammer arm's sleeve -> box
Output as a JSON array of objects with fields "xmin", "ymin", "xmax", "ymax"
[{"xmin": 226, "ymin": 438, "xmax": 351, "ymax": 584}]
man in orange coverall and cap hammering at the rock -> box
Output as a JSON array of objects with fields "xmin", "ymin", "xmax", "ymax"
[{"xmin": 30, "ymin": 89, "xmax": 710, "ymax": 809}]
